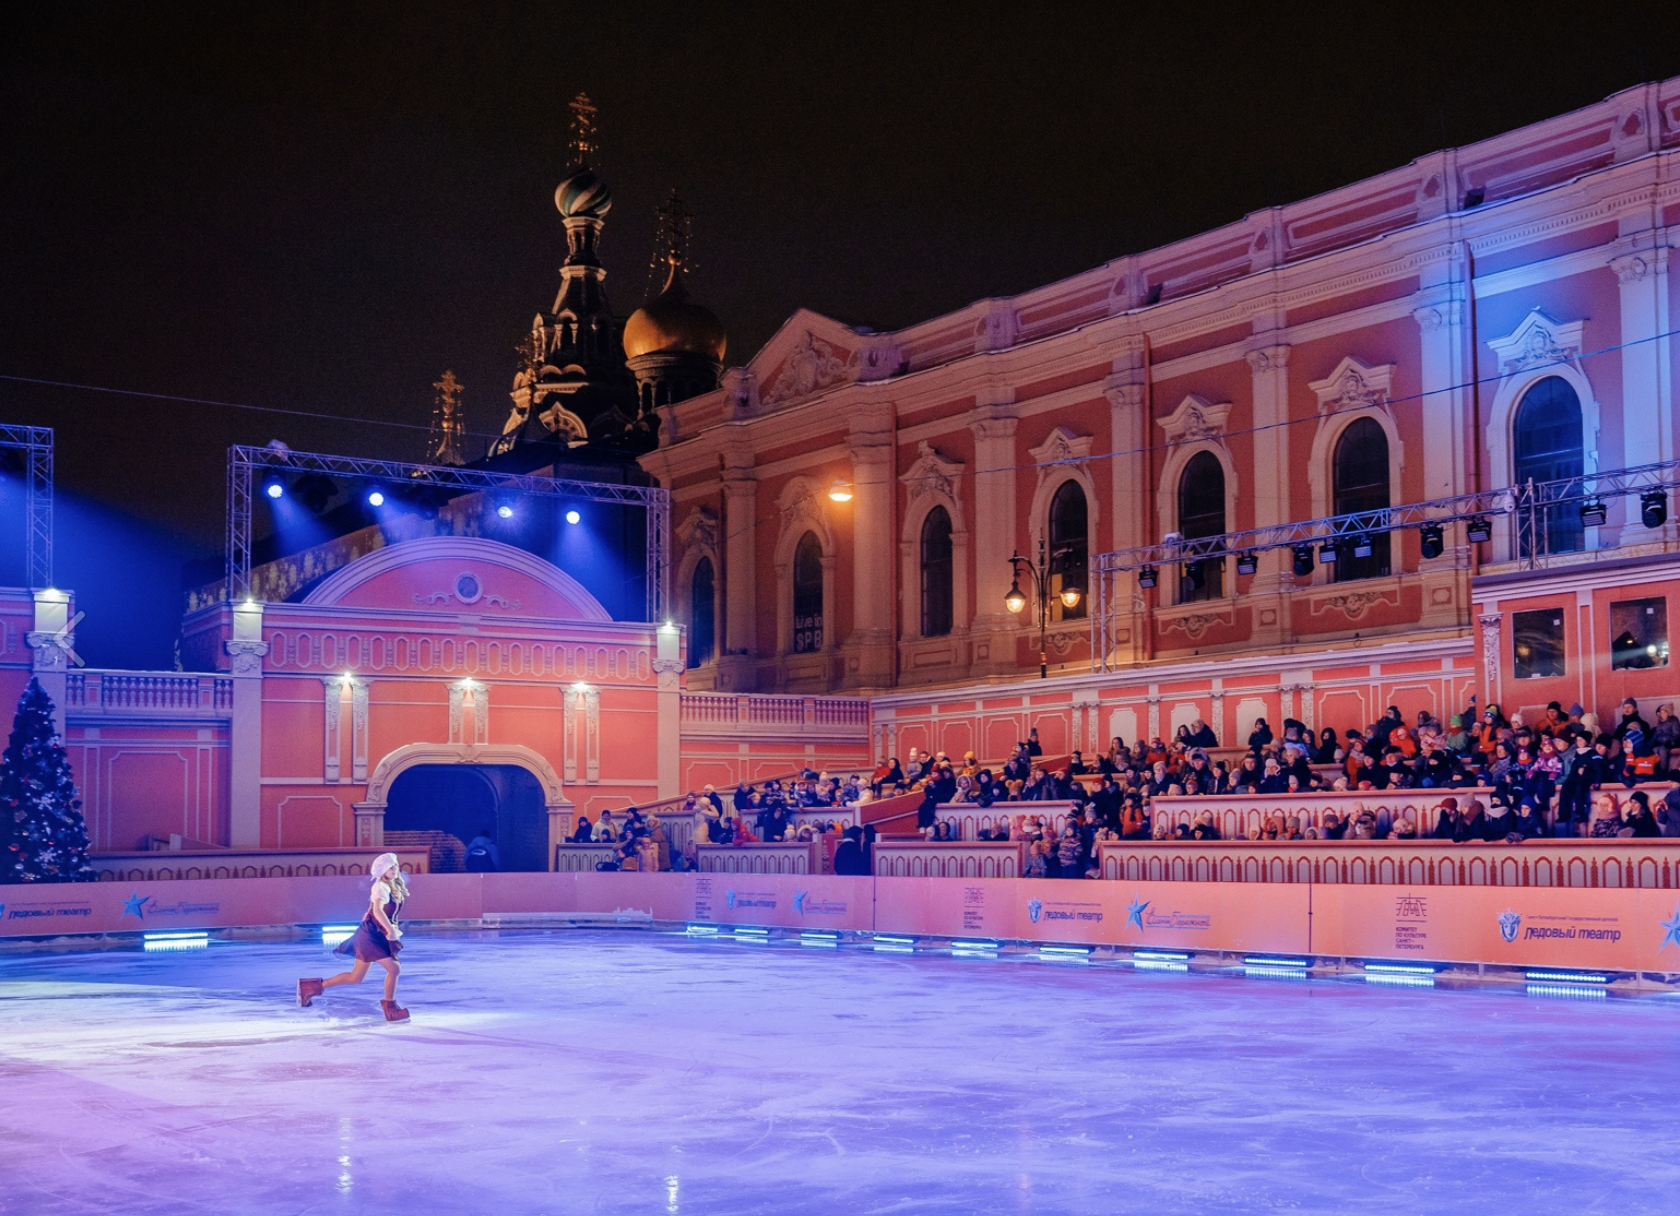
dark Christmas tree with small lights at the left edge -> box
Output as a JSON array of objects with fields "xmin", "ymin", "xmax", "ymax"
[{"xmin": 0, "ymin": 679, "xmax": 94, "ymax": 882}]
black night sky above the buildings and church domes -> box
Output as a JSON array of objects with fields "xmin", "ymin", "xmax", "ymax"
[{"xmin": 0, "ymin": 3, "xmax": 1680, "ymax": 667}]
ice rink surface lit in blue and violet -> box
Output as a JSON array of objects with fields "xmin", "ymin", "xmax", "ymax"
[{"xmin": 0, "ymin": 932, "xmax": 1680, "ymax": 1216}]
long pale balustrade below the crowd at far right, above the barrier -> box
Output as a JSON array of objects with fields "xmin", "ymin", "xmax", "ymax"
[{"xmin": 1097, "ymin": 838, "xmax": 1680, "ymax": 888}]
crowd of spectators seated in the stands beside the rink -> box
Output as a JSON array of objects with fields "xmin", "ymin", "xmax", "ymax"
[{"xmin": 573, "ymin": 697, "xmax": 1680, "ymax": 877}]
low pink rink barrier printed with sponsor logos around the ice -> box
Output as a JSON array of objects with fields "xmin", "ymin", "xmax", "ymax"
[{"xmin": 0, "ymin": 872, "xmax": 1680, "ymax": 974}]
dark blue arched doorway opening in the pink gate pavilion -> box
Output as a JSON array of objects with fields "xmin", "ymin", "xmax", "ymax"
[{"xmin": 385, "ymin": 764, "xmax": 549, "ymax": 873}]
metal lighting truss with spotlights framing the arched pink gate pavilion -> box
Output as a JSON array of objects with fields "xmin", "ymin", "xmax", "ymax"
[{"xmin": 228, "ymin": 443, "xmax": 670, "ymax": 621}]
